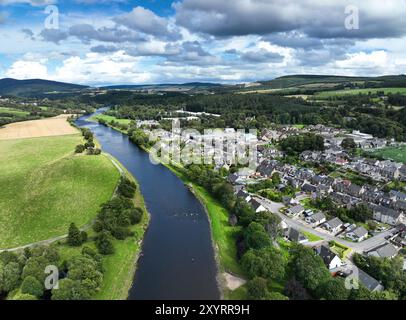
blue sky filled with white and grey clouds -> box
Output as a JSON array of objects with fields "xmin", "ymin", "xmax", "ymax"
[{"xmin": 0, "ymin": 0, "xmax": 406, "ymax": 86}]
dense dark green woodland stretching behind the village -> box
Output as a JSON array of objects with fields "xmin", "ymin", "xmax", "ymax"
[{"xmin": 81, "ymin": 91, "xmax": 406, "ymax": 141}]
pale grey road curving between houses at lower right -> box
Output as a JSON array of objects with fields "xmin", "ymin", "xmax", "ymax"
[{"xmin": 255, "ymin": 196, "xmax": 392, "ymax": 253}]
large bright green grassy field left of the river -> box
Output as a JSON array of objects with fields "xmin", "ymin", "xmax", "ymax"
[{"xmin": 0, "ymin": 134, "xmax": 120, "ymax": 249}]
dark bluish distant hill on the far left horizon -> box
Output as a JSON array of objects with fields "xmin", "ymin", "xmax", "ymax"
[{"xmin": 0, "ymin": 78, "xmax": 88, "ymax": 97}]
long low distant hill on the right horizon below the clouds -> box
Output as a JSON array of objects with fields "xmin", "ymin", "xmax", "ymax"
[{"xmin": 258, "ymin": 75, "xmax": 406, "ymax": 89}]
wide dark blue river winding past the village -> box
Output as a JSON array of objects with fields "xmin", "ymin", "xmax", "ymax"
[{"xmin": 76, "ymin": 109, "xmax": 220, "ymax": 300}]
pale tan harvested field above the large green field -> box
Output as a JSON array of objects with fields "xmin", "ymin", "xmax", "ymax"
[{"xmin": 0, "ymin": 115, "xmax": 78, "ymax": 140}]
